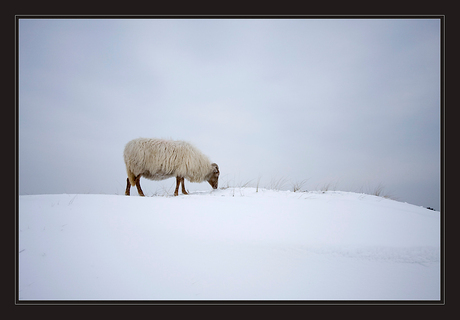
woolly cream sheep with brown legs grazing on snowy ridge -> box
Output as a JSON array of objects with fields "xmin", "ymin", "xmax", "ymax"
[{"xmin": 123, "ymin": 138, "xmax": 220, "ymax": 196}]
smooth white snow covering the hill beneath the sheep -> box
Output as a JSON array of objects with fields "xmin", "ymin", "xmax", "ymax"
[{"xmin": 18, "ymin": 188, "xmax": 441, "ymax": 301}]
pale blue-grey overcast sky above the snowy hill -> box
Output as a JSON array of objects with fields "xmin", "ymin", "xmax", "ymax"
[{"xmin": 19, "ymin": 19, "xmax": 441, "ymax": 210}]
